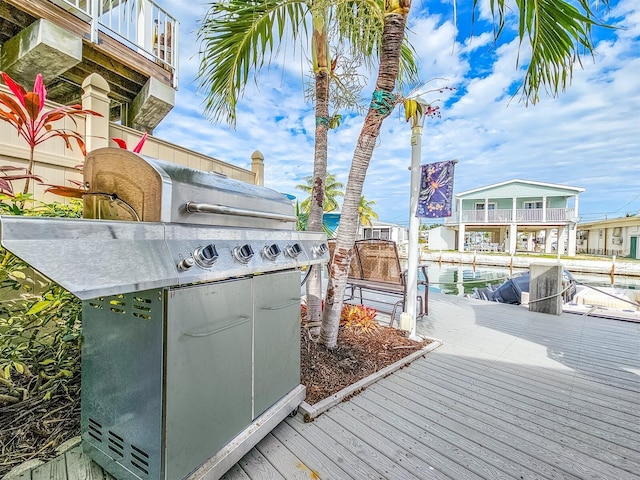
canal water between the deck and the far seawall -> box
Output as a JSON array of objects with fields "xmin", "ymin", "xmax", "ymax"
[{"xmin": 426, "ymin": 262, "xmax": 640, "ymax": 296}]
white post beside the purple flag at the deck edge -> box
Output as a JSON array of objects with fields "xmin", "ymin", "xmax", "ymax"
[{"xmin": 405, "ymin": 119, "xmax": 426, "ymax": 339}]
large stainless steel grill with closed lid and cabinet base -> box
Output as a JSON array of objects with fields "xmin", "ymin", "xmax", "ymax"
[{"xmin": 0, "ymin": 148, "xmax": 328, "ymax": 480}]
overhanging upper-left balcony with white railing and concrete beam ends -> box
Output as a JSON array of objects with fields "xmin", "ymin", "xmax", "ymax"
[{"xmin": 0, "ymin": 0, "xmax": 179, "ymax": 131}]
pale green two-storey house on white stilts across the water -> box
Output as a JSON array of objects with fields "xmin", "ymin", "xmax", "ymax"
[{"xmin": 445, "ymin": 179, "xmax": 584, "ymax": 255}]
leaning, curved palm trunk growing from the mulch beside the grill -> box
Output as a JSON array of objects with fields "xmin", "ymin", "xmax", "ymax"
[{"xmin": 320, "ymin": 0, "xmax": 411, "ymax": 348}]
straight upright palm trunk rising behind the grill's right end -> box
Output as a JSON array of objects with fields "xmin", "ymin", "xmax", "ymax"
[{"xmin": 307, "ymin": 8, "xmax": 329, "ymax": 322}]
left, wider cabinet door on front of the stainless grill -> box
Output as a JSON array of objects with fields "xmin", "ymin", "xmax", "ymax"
[{"xmin": 165, "ymin": 279, "xmax": 252, "ymax": 480}]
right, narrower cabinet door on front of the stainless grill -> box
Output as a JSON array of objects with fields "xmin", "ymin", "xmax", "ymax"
[{"xmin": 253, "ymin": 270, "xmax": 300, "ymax": 417}]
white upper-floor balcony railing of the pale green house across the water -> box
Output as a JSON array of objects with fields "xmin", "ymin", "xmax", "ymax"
[{"xmin": 445, "ymin": 208, "xmax": 574, "ymax": 225}]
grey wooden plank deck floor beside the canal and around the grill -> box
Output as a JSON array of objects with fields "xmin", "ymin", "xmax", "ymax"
[{"xmin": 11, "ymin": 294, "xmax": 640, "ymax": 480}]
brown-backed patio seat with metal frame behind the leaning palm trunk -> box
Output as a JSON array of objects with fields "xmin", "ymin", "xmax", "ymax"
[{"xmin": 329, "ymin": 239, "xmax": 429, "ymax": 325}]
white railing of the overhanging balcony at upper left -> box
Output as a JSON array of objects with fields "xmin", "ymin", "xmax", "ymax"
[{"xmin": 52, "ymin": 0, "xmax": 179, "ymax": 88}]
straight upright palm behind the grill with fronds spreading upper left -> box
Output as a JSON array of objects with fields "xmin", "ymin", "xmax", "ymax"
[{"xmin": 198, "ymin": 0, "xmax": 417, "ymax": 321}]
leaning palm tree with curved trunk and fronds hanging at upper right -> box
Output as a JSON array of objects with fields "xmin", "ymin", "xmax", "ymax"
[{"xmin": 320, "ymin": 0, "xmax": 608, "ymax": 348}]
